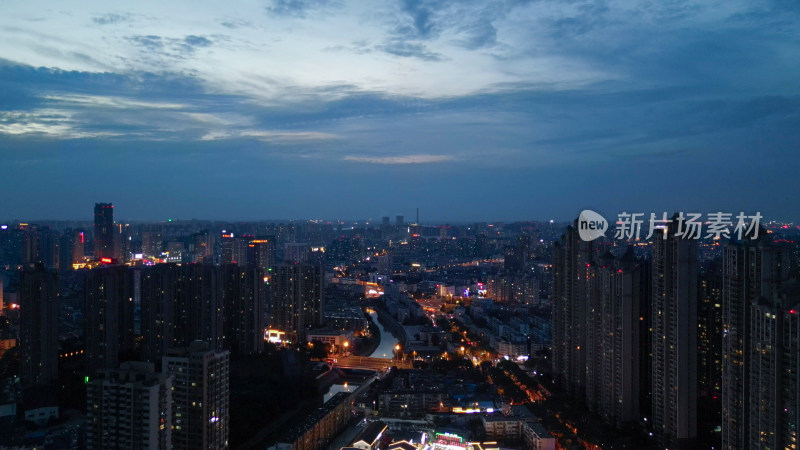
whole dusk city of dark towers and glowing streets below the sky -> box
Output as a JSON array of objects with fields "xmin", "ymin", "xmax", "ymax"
[{"xmin": 0, "ymin": 199, "xmax": 800, "ymax": 450}]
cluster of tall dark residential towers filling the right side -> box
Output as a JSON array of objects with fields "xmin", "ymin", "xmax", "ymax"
[{"xmin": 552, "ymin": 222, "xmax": 800, "ymax": 449}]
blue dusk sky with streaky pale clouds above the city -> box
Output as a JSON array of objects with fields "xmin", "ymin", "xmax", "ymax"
[{"xmin": 0, "ymin": 0, "xmax": 800, "ymax": 221}]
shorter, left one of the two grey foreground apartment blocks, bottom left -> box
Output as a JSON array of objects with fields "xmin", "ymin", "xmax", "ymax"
[{"xmin": 86, "ymin": 362, "xmax": 173, "ymax": 450}]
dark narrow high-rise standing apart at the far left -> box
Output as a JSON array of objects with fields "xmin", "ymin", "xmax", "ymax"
[{"xmin": 19, "ymin": 264, "xmax": 60, "ymax": 386}]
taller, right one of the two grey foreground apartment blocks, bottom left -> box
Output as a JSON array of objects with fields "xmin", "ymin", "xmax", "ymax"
[{"xmin": 162, "ymin": 341, "xmax": 230, "ymax": 449}]
